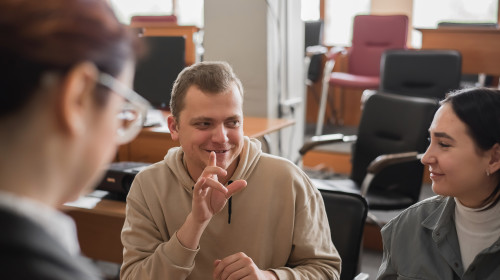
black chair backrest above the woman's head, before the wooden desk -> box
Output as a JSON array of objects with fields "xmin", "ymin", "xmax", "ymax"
[{"xmin": 379, "ymin": 50, "xmax": 462, "ymax": 100}]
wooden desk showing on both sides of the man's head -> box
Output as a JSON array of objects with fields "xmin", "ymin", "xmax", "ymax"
[{"xmin": 118, "ymin": 112, "xmax": 295, "ymax": 163}]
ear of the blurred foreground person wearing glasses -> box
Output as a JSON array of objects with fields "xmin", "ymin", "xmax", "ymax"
[{"xmin": 56, "ymin": 62, "xmax": 99, "ymax": 135}]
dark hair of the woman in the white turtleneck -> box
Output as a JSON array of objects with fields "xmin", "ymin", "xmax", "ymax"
[{"xmin": 441, "ymin": 88, "xmax": 500, "ymax": 210}]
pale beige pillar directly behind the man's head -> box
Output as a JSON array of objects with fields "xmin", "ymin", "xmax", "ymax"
[{"xmin": 203, "ymin": 0, "xmax": 267, "ymax": 116}]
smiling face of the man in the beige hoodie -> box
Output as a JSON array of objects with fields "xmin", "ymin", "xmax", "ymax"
[{"xmin": 168, "ymin": 85, "xmax": 243, "ymax": 180}]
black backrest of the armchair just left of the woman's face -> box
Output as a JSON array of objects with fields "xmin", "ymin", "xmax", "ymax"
[{"xmin": 351, "ymin": 92, "xmax": 439, "ymax": 203}]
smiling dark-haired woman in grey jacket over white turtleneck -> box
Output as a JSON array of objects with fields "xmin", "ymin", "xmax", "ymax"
[{"xmin": 378, "ymin": 88, "xmax": 500, "ymax": 280}]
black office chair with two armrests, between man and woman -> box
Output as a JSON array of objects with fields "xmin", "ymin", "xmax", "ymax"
[{"xmin": 299, "ymin": 93, "xmax": 438, "ymax": 210}]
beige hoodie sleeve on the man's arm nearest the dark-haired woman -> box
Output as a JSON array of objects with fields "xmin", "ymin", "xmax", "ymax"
[{"xmin": 272, "ymin": 183, "xmax": 341, "ymax": 279}]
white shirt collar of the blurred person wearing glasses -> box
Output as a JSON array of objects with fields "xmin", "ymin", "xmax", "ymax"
[{"xmin": 0, "ymin": 191, "xmax": 80, "ymax": 255}]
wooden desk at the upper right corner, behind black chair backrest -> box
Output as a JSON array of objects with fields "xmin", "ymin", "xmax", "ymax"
[{"xmin": 417, "ymin": 27, "xmax": 500, "ymax": 76}]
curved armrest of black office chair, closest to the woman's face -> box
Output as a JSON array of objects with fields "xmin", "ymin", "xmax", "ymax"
[{"xmin": 361, "ymin": 152, "xmax": 423, "ymax": 196}]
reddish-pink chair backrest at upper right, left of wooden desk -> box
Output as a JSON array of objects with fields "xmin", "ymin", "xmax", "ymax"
[{"xmin": 349, "ymin": 15, "xmax": 408, "ymax": 77}]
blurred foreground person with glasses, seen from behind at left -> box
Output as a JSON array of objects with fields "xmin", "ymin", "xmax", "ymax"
[{"xmin": 0, "ymin": 0, "xmax": 148, "ymax": 279}]
